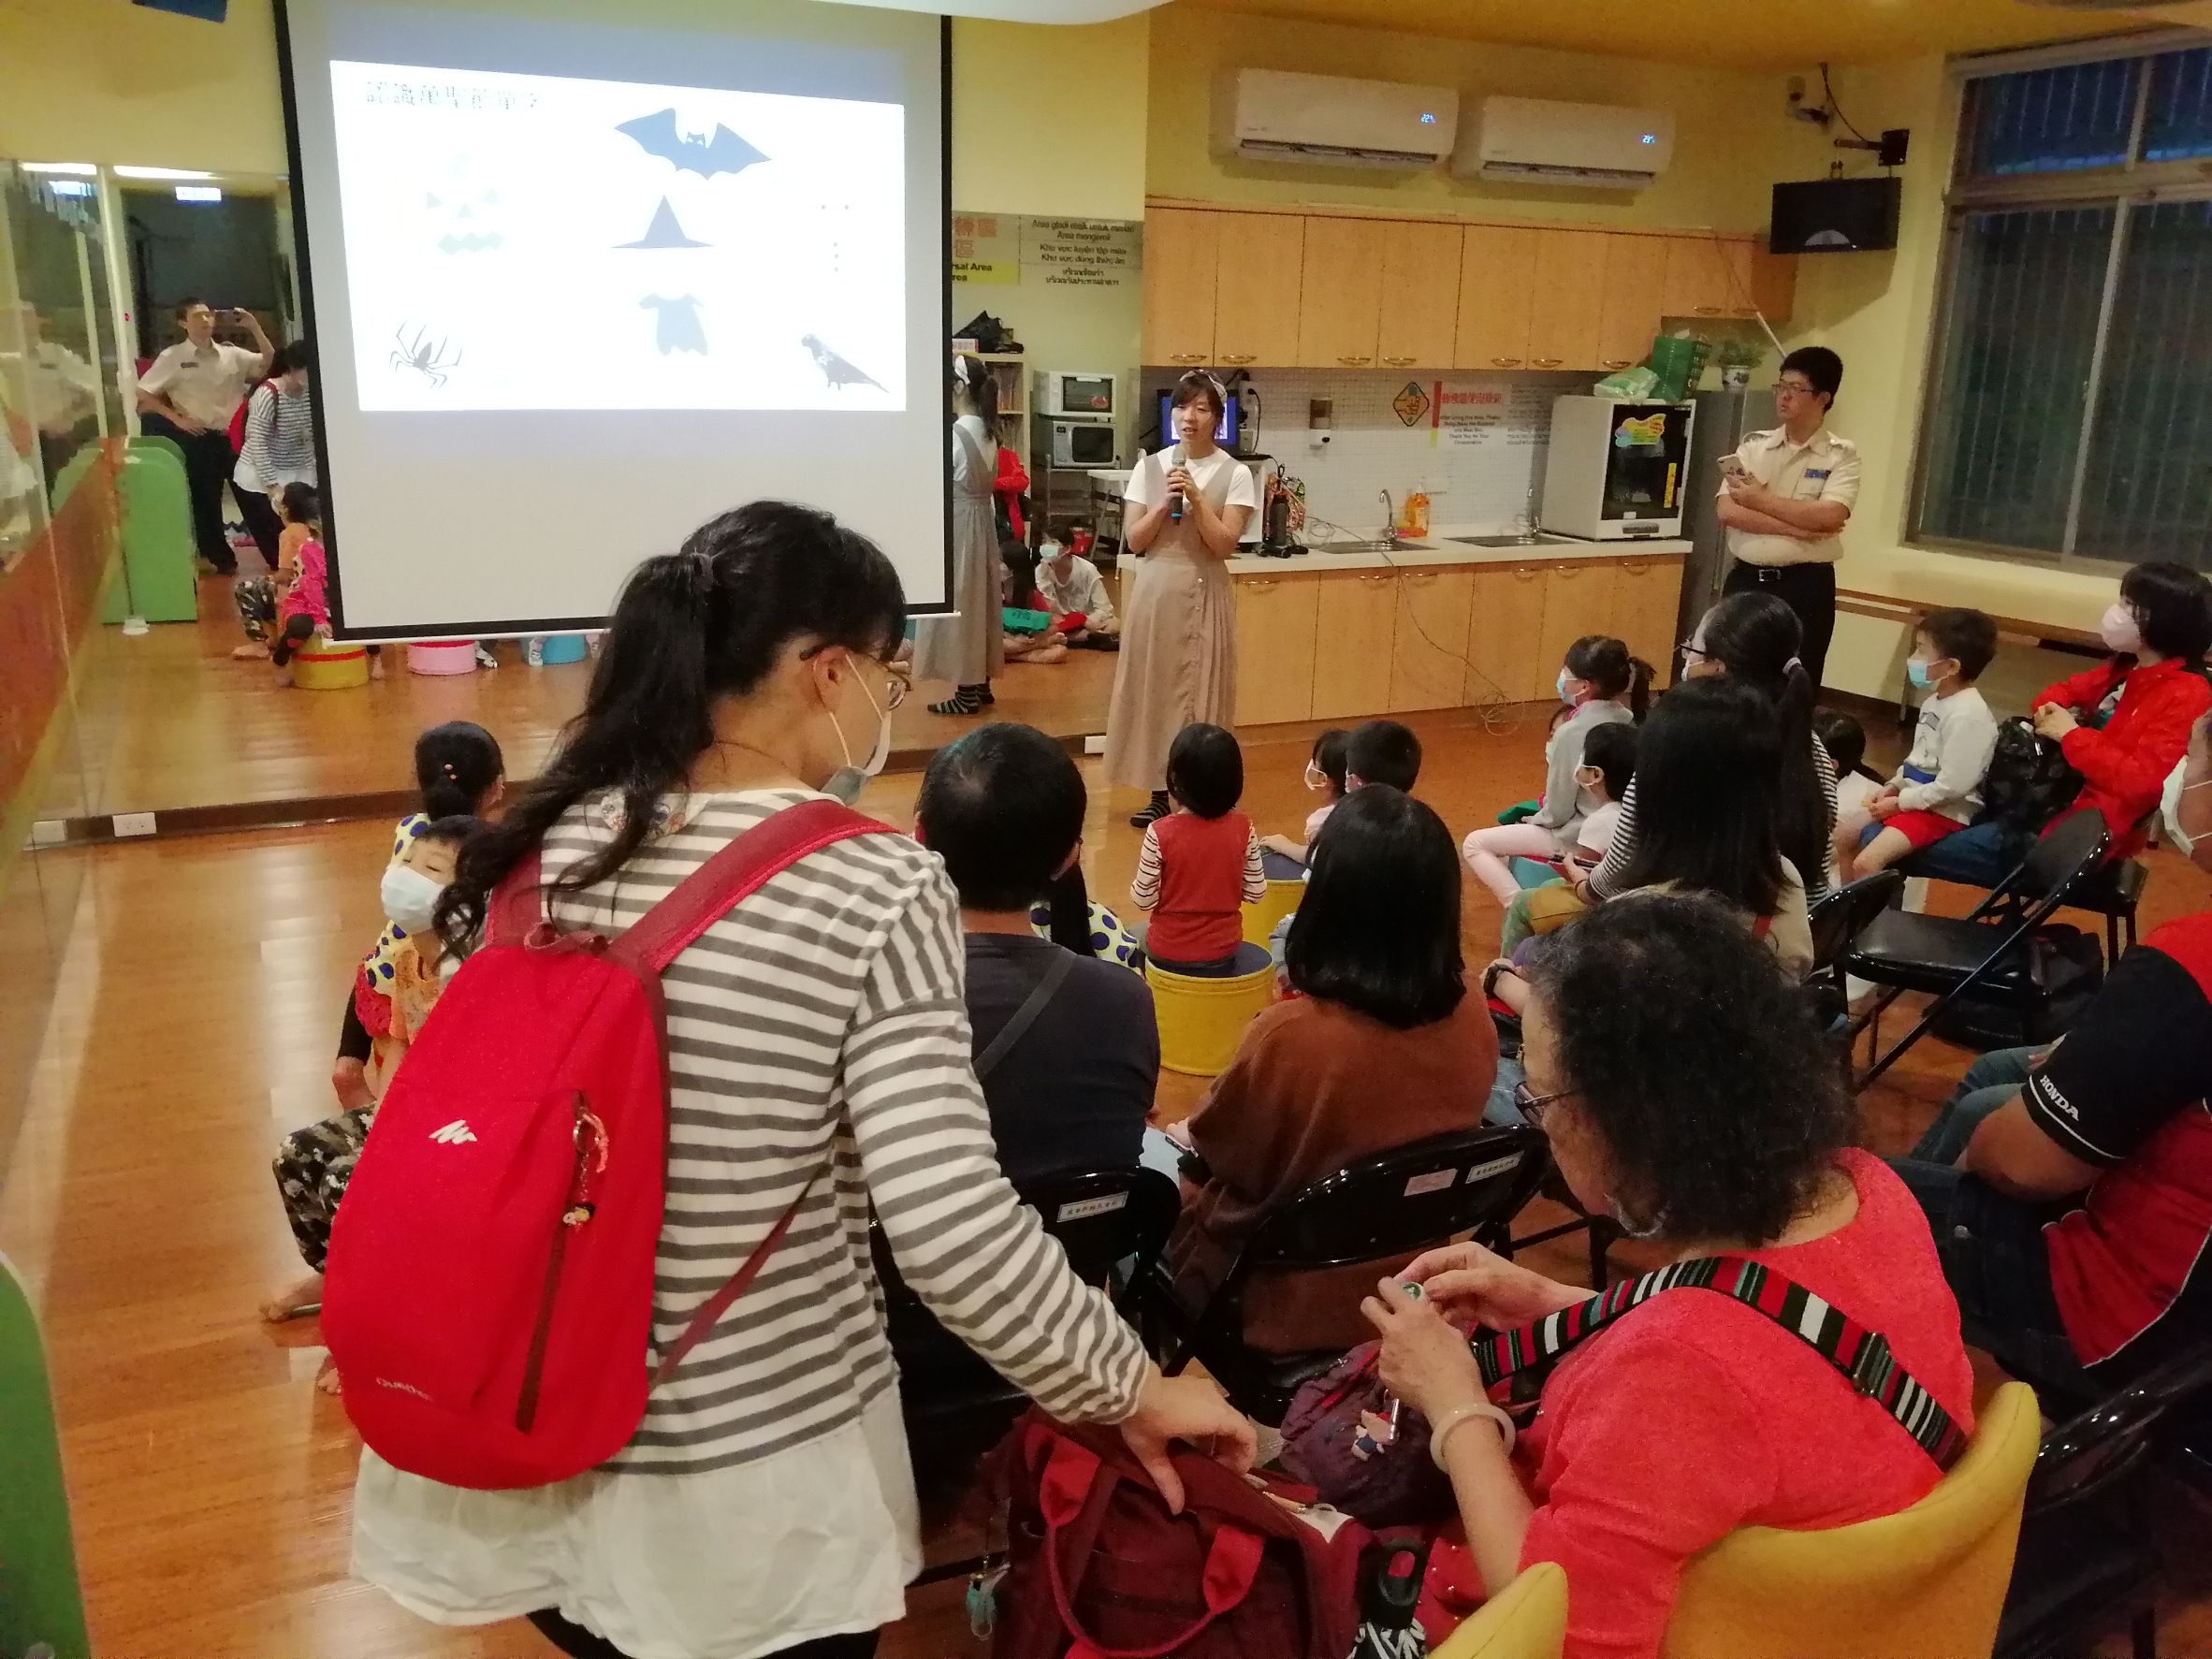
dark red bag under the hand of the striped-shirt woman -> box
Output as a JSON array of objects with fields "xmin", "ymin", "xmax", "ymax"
[{"xmin": 991, "ymin": 1411, "xmax": 1374, "ymax": 1659}]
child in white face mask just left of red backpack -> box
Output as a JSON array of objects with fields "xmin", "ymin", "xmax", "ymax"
[{"xmin": 261, "ymin": 816, "xmax": 485, "ymax": 1393}]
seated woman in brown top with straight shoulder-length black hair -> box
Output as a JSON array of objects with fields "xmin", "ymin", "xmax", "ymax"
[{"xmin": 1168, "ymin": 783, "xmax": 1497, "ymax": 1354}]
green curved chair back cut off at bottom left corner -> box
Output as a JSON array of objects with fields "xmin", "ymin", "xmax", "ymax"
[{"xmin": 0, "ymin": 1257, "xmax": 93, "ymax": 1659}]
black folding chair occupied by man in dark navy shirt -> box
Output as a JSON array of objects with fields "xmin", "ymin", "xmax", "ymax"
[{"xmin": 869, "ymin": 1166, "xmax": 1181, "ymax": 1438}]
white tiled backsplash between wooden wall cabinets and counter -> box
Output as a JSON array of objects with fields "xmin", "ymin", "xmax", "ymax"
[{"xmin": 1146, "ymin": 370, "xmax": 1594, "ymax": 535}]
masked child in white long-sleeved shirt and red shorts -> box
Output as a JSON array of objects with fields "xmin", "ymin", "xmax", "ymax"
[{"xmin": 1838, "ymin": 608, "xmax": 1998, "ymax": 880}]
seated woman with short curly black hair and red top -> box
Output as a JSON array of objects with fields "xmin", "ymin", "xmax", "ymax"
[{"xmin": 1362, "ymin": 902, "xmax": 1973, "ymax": 1659}]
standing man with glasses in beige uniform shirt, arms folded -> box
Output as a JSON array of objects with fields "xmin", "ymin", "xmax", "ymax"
[{"xmin": 1721, "ymin": 345, "xmax": 1858, "ymax": 691}]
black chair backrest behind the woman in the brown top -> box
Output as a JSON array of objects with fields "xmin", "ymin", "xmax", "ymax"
[{"xmin": 1223, "ymin": 1124, "xmax": 1546, "ymax": 1288}]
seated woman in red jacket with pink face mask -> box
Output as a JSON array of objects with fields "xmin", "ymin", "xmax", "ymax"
[{"xmin": 1902, "ymin": 560, "xmax": 2212, "ymax": 887}]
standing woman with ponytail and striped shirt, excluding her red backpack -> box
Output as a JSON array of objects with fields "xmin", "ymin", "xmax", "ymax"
[{"xmin": 354, "ymin": 502, "xmax": 1250, "ymax": 1659}]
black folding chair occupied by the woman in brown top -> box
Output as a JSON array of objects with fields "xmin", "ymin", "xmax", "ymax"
[{"xmin": 1148, "ymin": 1126, "xmax": 1549, "ymax": 1422}]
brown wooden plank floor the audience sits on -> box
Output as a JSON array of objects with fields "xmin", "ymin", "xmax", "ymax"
[{"xmin": 12, "ymin": 716, "xmax": 2212, "ymax": 1659}]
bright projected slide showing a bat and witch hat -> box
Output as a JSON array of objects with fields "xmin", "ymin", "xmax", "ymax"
[{"xmin": 329, "ymin": 60, "xmax": 897, "ymax": 414}]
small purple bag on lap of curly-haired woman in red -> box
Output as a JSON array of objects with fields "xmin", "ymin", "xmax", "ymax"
[{"xmin": 1283, "ymin": 1343, "xmax": 1456, "ymax": 1529}]
